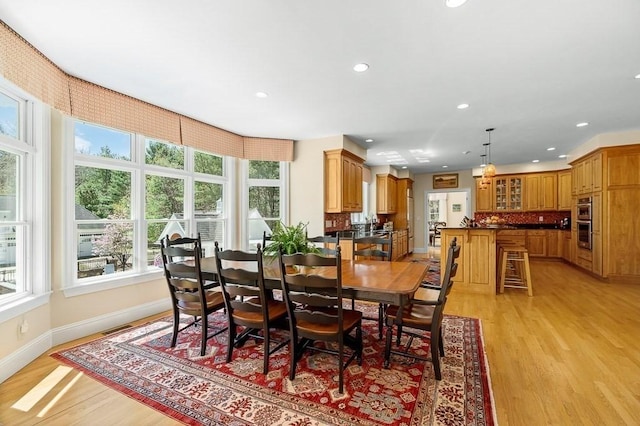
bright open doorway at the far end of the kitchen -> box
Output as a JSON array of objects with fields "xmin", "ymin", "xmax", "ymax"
[{"xmin": 423, "ymin": 189, "xmax": 471, "ymax": 248}]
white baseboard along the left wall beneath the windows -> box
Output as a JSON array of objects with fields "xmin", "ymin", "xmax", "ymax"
[{"xmin": 0, "ymin": 298, "xmax": 171, "ymax": 383}]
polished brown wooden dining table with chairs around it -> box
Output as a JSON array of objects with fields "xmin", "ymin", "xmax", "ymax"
[{"xmin": 200, "ymin": 257, "xmax": 428, "ymax": 306}]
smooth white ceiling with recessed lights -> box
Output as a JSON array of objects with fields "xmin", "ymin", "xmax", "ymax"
[{"xmin": 0, "ymin": 0, "xmax": 640, "ymax": 173}]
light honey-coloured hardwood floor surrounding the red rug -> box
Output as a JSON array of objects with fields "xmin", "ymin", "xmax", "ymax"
[{"xmin": 0, "ymin": 255, "xmax": 640, "ymax": 426}]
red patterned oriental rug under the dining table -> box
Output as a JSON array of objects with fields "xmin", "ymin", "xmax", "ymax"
[{"xmin": 52, "ymin": 307, "xmax": 496, "ymax": 426}]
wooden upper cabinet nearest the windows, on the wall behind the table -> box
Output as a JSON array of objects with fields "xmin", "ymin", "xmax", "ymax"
[{"xmin": 324, "ymin": 149, "xmax": 364, "ymax": 213}]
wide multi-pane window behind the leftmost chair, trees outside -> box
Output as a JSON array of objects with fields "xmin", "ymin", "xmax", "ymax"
[{"xmin": 70, "ymin": 120, "xmax": 228, "ymax": 290}]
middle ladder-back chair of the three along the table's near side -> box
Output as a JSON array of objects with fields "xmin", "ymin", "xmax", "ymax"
[{"xmin": 214, "ymin": 242, "xmax": 289, "ymax": 374}]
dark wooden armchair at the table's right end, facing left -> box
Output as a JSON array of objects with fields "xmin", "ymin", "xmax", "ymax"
[{"xmin": 384, "ymin": 238, "xmax": 460, "ymax": 380}]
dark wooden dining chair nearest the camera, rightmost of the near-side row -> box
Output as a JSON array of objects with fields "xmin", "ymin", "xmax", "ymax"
[{"xmin": 279, "ymin": 246, "xmax": 362, "ymax": 393}]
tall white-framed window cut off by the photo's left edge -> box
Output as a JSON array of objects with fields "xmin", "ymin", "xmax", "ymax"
[{"xmin": 0, "ymin": 80, "xmax": 50, "ymax": 321}]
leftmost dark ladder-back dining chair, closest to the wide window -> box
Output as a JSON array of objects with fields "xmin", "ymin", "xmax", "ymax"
[{"xmin": 160, "ymin": 238, "xmax": 226, "ymax": 356}]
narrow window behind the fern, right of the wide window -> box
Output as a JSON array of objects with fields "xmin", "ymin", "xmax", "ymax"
[{"xmin": 245, "ymin": 160, "xmax": 288, "ymax": 250}]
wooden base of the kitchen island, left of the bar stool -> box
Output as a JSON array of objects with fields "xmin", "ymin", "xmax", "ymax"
[{"xmin": 440, "ymin": 228, "xmax": 499, "ymax": 295}]
